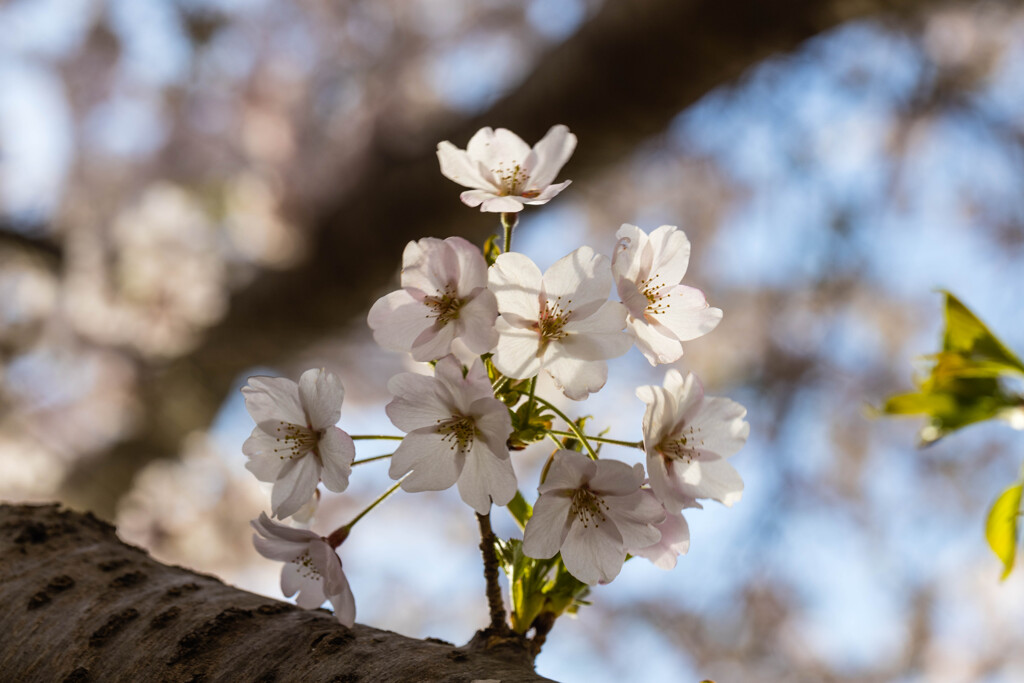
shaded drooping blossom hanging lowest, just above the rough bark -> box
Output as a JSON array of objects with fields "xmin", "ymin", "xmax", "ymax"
[{"xmin": 250, "ymin": 512, "xmax": 355, "ymax": 628}]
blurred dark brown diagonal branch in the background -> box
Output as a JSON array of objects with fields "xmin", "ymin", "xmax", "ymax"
[{"xmin": 63, "ymin": 0, "xmax": 940, "ymax": 517}]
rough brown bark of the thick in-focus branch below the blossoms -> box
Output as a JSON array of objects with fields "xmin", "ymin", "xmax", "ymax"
[{"xmin": 0, "ymin": 505, "xmax": 548, "ymax": 683}]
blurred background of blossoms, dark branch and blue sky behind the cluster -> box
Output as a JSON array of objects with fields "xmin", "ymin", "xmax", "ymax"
[{"xmin": 0, "ymin": 0, "xmax": 1024, "ymax": 683}]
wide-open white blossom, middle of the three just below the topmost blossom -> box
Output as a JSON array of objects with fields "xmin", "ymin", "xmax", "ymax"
[{"xmin": 487, "ymin": 247, "xmax": 632, "ymax": 400}]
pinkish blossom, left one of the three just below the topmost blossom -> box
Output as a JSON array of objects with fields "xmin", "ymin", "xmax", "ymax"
[{"xmin": 367, "ymin": 238, "xmax": 498, "ymax": 361}]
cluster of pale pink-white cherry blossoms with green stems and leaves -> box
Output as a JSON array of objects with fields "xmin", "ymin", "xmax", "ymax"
[{"xmin": 243, "ymin": 126, "xmax": 750, "ymax": 634}]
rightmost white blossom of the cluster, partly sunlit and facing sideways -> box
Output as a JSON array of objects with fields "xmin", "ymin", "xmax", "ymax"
[{"xmin": 637, "ymin": 370, "xmax": 751, "ymax": 512}]
